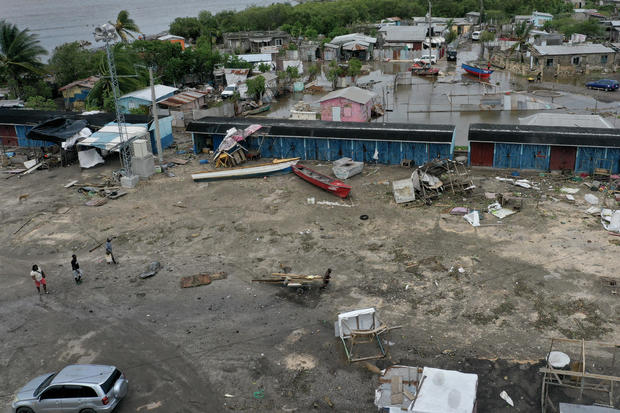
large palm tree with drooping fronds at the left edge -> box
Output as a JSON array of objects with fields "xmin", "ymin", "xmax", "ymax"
[{"xmin": 0, "ymin": 20, "xmax": 47, "ymax": 96}]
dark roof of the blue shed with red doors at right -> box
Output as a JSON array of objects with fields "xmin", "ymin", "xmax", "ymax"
[{"xmin": 468, "ymin": 123, "xmax": 620, "ymax": 148}]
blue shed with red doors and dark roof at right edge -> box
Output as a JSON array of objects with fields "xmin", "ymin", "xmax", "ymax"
[{"xmin": 468, "ymin": 124, "xmax": 620, "ymax": 174}]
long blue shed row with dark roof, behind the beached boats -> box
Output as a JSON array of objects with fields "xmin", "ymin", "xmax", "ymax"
[{"xmin": 187, "ymin": 117, "xmax": 455, "ymax": 165}]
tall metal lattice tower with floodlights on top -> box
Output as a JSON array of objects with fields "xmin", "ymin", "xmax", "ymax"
[{"xmin": 94, "ymin": 23, "xmax": 133, "ymax": 176}]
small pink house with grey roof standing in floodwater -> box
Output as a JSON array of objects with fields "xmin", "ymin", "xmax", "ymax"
[{"xmin": 319, "ymin": 86, "xmax": 375, "ymax": 122}]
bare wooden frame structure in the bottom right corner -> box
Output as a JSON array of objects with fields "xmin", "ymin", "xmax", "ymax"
[{"xmin": 539, "ymin": 338, "xmax": 620, "ymax": 413}]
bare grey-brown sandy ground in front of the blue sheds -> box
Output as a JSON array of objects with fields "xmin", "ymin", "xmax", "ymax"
[{"xmin": 0, "ymin": 143, "xmax": 620, "ymax": 413}]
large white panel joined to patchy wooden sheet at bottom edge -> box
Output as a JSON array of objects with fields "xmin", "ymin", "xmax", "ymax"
[{"xmin": 375, "ymin": 365, "xmax": 478, "ymax": 413}]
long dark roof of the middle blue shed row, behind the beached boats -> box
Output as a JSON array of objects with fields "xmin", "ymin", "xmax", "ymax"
[{"xmin": 187, "ymin": 117, "xmax": 454, "ymax": 144}]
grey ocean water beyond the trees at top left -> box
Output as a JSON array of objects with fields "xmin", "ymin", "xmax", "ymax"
[{"xmin": 0, "ymin": 0, "xmax": 288, "ymax": 54}]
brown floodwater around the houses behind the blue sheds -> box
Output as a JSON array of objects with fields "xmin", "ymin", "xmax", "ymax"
[{"xmin": 267, "ymin": 44, "xmax": 620, "ymax": 146}]
